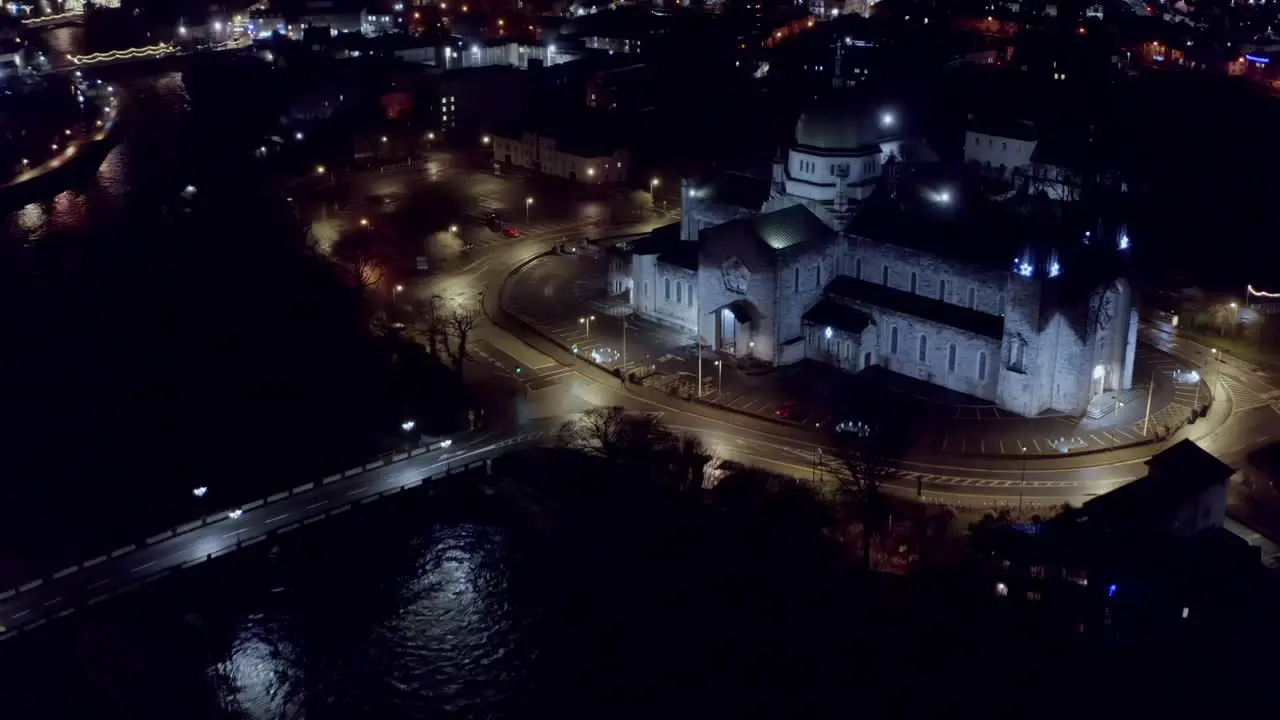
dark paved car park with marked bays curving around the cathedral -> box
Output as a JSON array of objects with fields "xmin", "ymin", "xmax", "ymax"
[{"xmin": 504, "ymin": 255, "xmax": 1211, "ymax": 459}]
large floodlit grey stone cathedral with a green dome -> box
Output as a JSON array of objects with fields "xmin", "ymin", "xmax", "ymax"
[{"xmin": 608, "ymin": 99, "xmax": 1138, "ymax": 415}]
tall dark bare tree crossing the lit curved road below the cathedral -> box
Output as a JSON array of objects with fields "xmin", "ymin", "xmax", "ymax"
[{"xmin": 831, "ymin": 425, "xmax": 892, "ymax": 569}]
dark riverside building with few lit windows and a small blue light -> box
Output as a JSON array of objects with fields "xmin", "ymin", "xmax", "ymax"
[{"xmin": 974, "ymin": 439, "xmax": 1262, "ymax": 633}]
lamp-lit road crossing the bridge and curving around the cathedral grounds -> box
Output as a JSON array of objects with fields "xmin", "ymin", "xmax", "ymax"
[{"xmin": 0, "ymin": 156, "xmax": 1280, "ymax": 638}]
